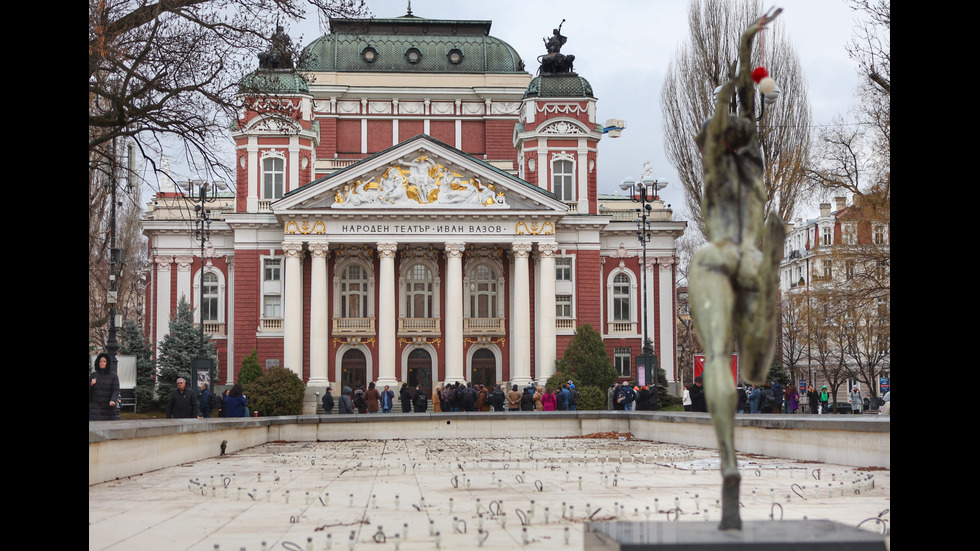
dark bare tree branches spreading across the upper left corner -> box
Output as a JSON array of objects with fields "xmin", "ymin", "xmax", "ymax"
[{"xmin": 88, "ymin": 0, "xmax": 366, "ymax": 189}]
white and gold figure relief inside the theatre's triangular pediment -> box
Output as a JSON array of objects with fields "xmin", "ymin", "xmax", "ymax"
[{"xmin": 333, "ymin": 155, "xmax": 507, "ymax": 208}]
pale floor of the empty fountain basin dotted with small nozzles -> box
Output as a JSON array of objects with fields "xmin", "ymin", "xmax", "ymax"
[{"xmin": 89, "ymin": 433, "xmax": 891, "ymax": 551}]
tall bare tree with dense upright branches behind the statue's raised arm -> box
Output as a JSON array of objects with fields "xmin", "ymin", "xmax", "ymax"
[{"xmin": 660, "ymin": 0, "xmax": 811, "ymax": 234}]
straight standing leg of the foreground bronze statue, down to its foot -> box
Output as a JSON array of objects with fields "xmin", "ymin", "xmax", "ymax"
[{"xmin": 689, "ymin": 244, "xmax": 742, "ymax": 530}]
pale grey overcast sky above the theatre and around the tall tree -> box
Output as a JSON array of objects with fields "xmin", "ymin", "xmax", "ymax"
[{"xmin": 280, "ymin": 0, "xmax": 859, "ymax": 222}]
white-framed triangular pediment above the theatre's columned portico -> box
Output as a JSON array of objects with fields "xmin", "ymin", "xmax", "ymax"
[{"xmin": 272, "ymin": 134, "xmax": 568, "ymax": 215}]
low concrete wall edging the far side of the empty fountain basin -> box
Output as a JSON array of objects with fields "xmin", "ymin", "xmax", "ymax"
[{"xmin": 89, "ymin": 411, "xmax": 891, "ymax": 484}]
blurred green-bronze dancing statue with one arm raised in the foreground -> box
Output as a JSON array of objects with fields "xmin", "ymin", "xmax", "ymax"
[{"xmin": 690, "ymin": 9, "xmax": 785, "ymax": 530}]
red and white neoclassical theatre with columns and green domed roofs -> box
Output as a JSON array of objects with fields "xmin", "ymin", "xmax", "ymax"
[{"xmin": 144, "ymin": 7, "xmax": 686, "ymax": 407}]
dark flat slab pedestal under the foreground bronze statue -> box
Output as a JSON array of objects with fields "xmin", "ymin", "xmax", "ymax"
[{"xmin": 584, "ymin": 520, "xmax": 887, "ymax": 551}]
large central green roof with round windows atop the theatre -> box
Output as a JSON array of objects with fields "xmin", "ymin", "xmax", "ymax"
[{"xmin": 298, "ymin": 15, "xmax": 525, "ymax": 73}]
